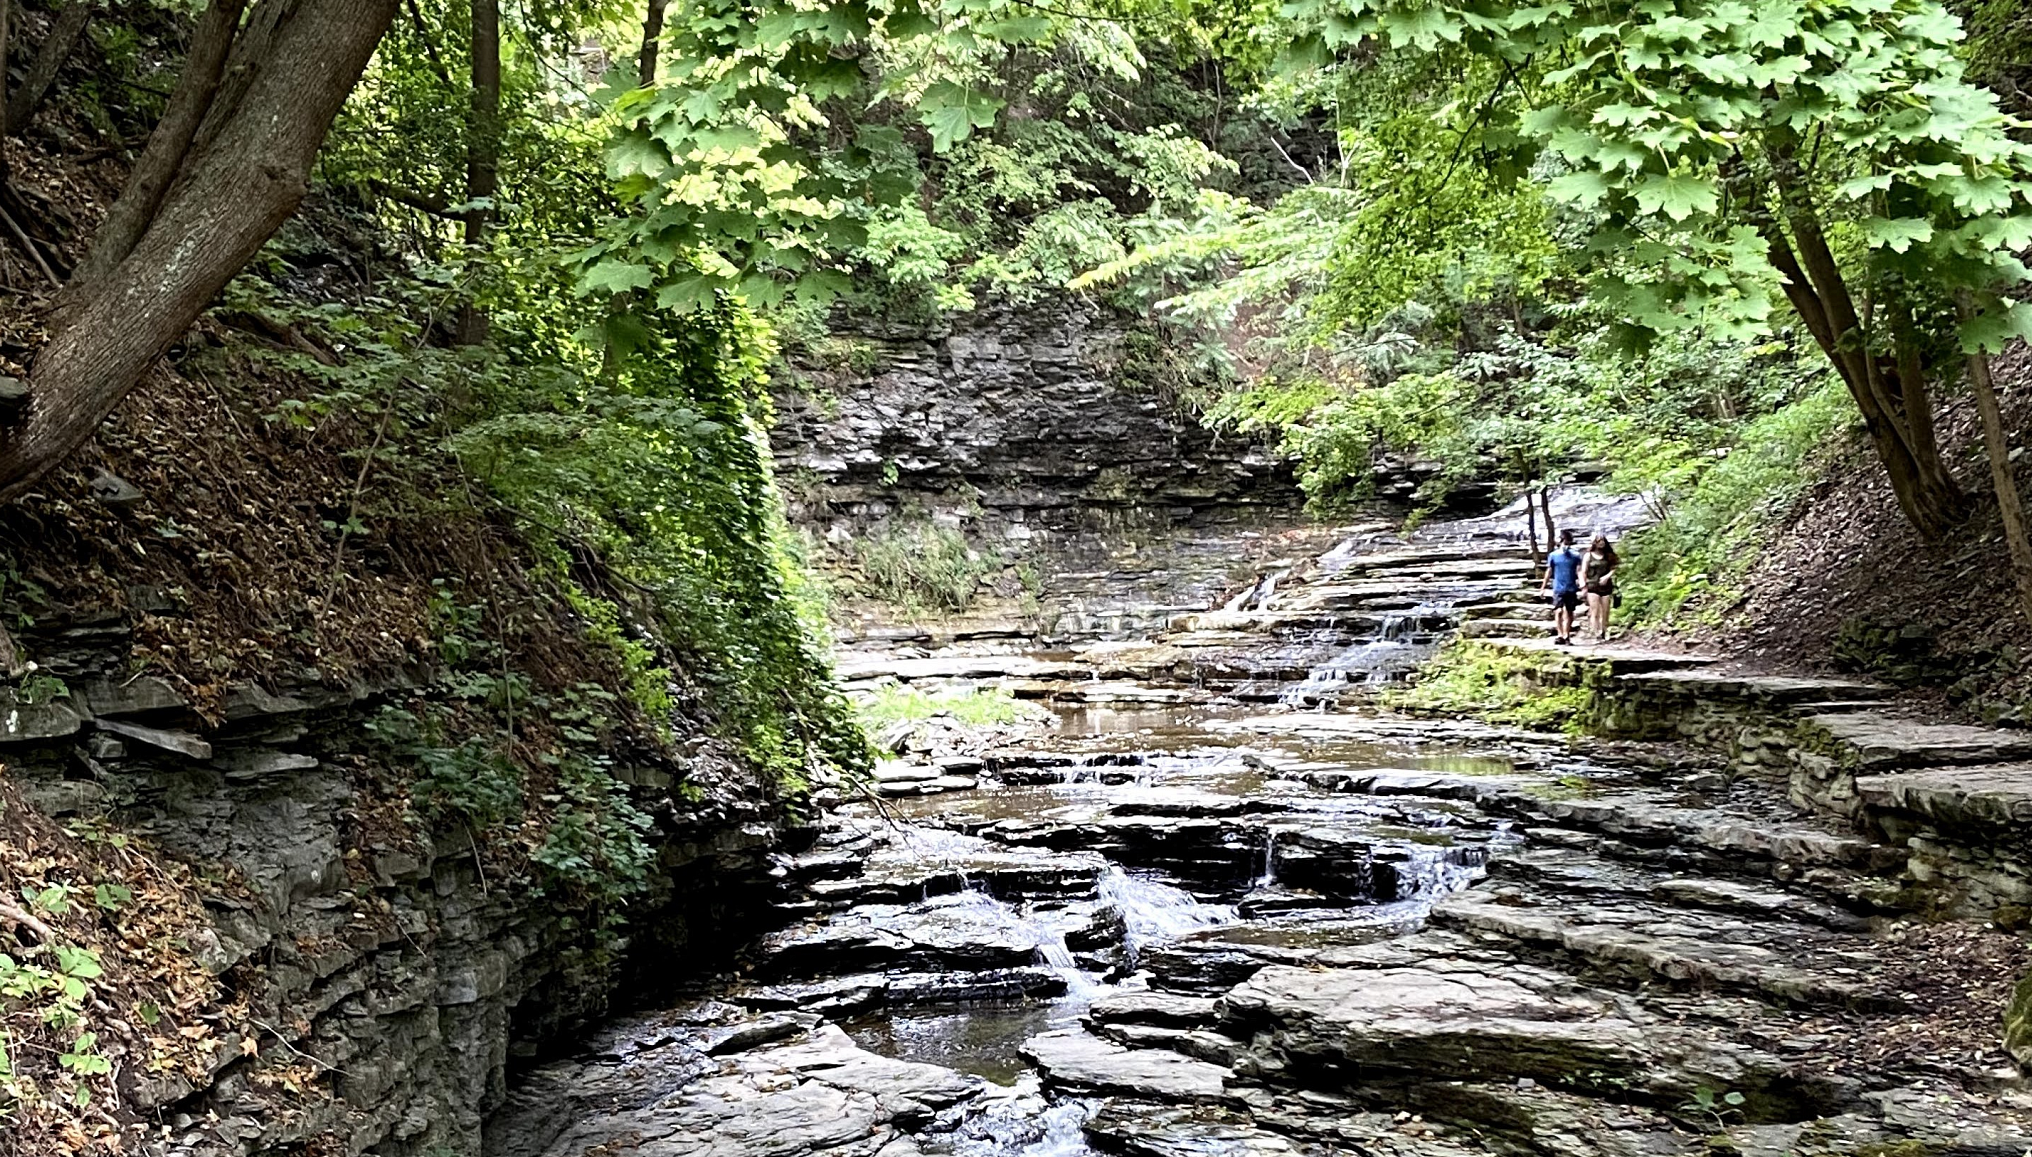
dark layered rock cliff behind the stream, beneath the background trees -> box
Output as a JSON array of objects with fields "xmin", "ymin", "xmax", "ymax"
[{"xmin": 770, "ymin": 297, "xmax": 1300, "ymax": 539}]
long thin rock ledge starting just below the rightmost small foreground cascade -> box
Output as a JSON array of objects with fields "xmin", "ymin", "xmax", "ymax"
[{"xmin": 1431, "ymin": 889, "xmax": 1902, "ymax": 1009}]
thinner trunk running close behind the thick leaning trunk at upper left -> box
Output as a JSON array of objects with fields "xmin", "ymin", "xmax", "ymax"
[{"xmin": 63, "ymin": 0, "xmax": 244, "ymax": 303}]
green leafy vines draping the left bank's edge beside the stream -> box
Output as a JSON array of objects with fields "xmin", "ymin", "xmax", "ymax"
[{"xmin": 451, "ymin": 301, "xmax": 866, "ymax": 785}]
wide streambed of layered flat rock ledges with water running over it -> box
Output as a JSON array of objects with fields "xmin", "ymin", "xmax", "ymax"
[{"xmin": 488, "ymin": 510, "xmax": 2032, "ymax": 1157}]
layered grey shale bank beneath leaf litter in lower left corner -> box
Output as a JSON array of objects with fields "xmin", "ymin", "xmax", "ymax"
[{"xmin": 0, "ymin": 589, "xmax": 786, "ymax": 1157}]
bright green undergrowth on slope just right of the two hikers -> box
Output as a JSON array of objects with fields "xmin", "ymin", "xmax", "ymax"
[{"xmin": 1615, "ymin": 384, "xmax": 1855, "ymax": 626}]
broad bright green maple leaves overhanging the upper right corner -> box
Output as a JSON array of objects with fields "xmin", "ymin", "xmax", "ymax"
[{"xmin": 1286, "ymin": 0, "xmax": 2032, "ymax": 346}]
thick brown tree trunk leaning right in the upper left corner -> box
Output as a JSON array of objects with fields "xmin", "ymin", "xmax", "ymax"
[{"xmin": 0, "ymin": 0, "xmax": 396, "ymax": 502}]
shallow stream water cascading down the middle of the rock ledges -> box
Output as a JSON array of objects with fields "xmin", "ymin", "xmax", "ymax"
[{"xmin": 548, "ymin": 488, "xmax": 1674, "ymax": 1157}]
